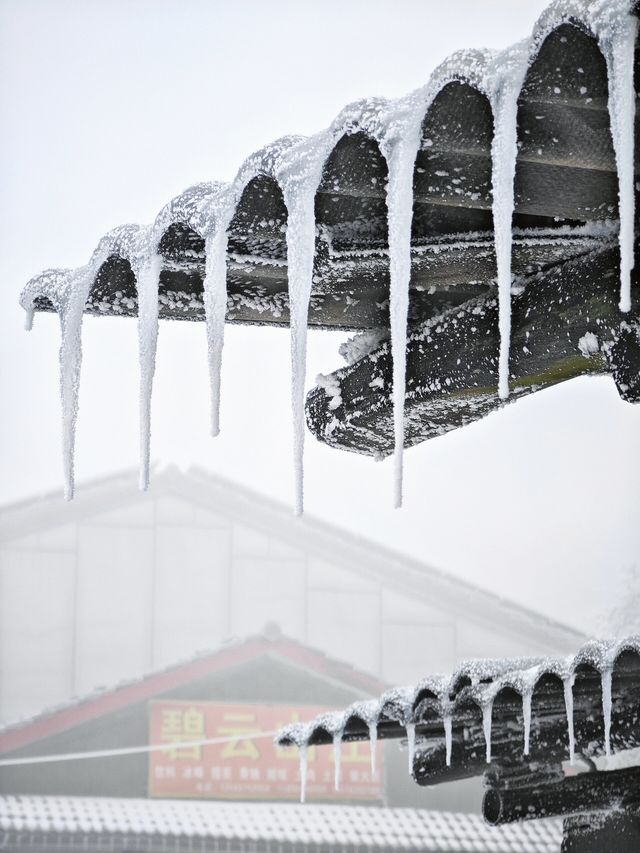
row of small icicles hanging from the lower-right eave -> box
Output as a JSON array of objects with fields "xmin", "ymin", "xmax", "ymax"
[{"xmin": 298, "ymin": 668, "xmax": 612, "ymax": 803}]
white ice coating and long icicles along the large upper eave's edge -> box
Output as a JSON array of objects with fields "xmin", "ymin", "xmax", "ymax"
[{"xmin": 20, "ymin": 0, "xmax": 638, "ymax": 513}]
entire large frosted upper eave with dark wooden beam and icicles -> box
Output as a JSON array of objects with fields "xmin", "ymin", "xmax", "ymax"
[{"xmin": 22, "ymin": 0, "xmax": 638, "ymax": 513}]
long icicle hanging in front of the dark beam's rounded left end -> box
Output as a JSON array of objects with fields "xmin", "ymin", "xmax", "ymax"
[{"xmin": 387, "ymin": 145, "xmax": 417, "ymax": 508}]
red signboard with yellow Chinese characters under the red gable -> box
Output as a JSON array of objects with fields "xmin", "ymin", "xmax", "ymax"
[{"xmin": 149, "ymin": 700, "xmax": 382, "ymax": 800}]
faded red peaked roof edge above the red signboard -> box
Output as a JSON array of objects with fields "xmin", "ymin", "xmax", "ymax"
[{"xmin": 0, "ymin": 629, "xmax": 388, "ymax": 755}]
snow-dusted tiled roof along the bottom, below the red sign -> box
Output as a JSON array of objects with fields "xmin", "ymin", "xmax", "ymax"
[{"xmin": 0, "ymin": 796, "xmax": 562, "ymax": 853}]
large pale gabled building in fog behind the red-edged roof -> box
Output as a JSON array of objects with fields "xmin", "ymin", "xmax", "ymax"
[{"xmin": 0, "ymin": 468, "xmax": 584, "ymax": 723}]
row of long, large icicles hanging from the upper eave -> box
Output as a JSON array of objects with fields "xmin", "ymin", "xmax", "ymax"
[{"xmin": 28, "ymin": 5, "xmax": 637, "ymax": 515}]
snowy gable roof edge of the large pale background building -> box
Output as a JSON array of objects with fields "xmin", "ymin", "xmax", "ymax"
[{"xmin": 0, "ymin": 465, "xmax": 587, "ymax": 654}]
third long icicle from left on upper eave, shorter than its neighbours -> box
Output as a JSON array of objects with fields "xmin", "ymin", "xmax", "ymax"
[{"xmin": 204, "ymin": 222, "xmax": 227, "ymax": 436}]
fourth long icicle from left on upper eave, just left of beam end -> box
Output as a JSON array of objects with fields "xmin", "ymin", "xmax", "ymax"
[{"xmin": 285, "ymin": 191, "xmax": 316, "ymax": 515}]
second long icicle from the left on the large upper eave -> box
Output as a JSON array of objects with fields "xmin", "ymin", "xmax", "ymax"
[{"xmin": 138, "ymin": 251, "xmax": 162, "ymax": 491}]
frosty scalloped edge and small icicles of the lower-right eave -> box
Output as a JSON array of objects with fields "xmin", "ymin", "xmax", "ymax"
[{"xmin": 276, "ymin": 635, "xmax": 640, "ymax": 799}]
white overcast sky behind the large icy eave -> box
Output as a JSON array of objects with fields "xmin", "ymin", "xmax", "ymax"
[{"xmin": 0, "ymin": 0, "xmax": 640, "ymax": 630}]
